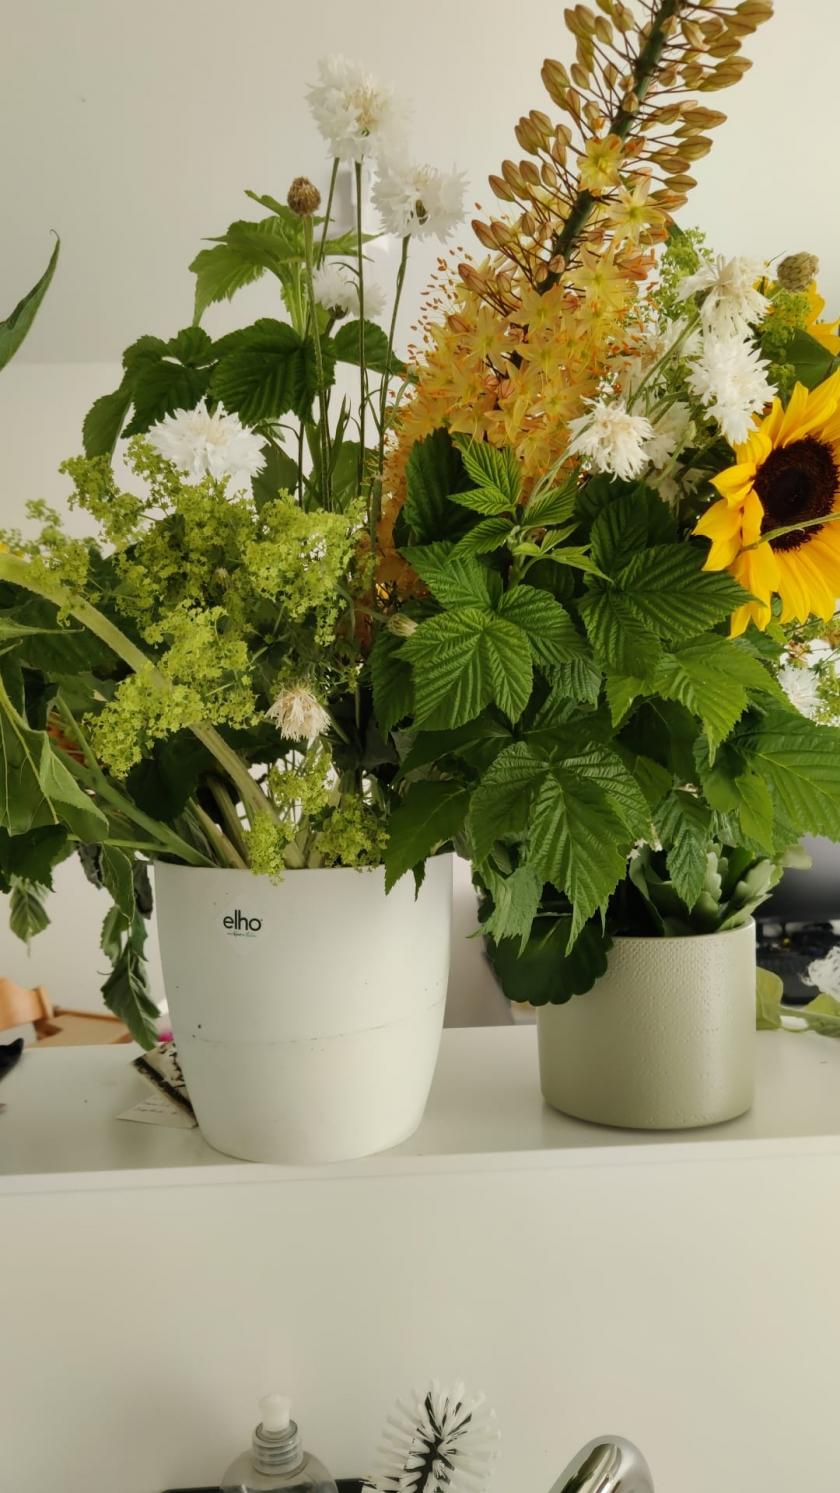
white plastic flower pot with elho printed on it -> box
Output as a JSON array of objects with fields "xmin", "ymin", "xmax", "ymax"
[{"xmin": 155, "ymin": 855, "xmax": 452, "ymax": 1163}]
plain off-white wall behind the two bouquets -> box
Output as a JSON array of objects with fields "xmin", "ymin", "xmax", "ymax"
[{"xmin": 0, "ymin": 0, "xmax": 840, "ymax": 1009}]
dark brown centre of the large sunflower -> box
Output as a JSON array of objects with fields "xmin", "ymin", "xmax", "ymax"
[{"xmin": 755, "ymin": 436, "xmax": 840, "ymax": 549}]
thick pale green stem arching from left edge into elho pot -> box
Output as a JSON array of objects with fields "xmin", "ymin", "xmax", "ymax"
[{"xmin": 0, "ymin": 554, "xmax": 273, "ymax": 814}]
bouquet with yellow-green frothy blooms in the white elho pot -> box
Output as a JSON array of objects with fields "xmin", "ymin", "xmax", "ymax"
[{"xmin": 0, "ymin": 58, "xmax": 463, "ymax": 1045}]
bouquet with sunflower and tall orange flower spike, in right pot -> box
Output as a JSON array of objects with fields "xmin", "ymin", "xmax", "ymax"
[{"xmin": 372, "ymin": 0, "xmax": 840, "ymax": 1003}]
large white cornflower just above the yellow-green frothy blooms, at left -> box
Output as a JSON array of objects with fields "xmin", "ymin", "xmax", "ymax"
[{"xmin": 146, "ymin": 400, "xmax": 266, "ymax": 491}]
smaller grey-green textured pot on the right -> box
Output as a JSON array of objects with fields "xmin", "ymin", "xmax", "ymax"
[{"xmin": 537, "ymin": 923, "xmax": 755, "ymax": 1130}]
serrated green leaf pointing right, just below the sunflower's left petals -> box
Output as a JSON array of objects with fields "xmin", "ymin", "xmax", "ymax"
[{"xmin": 616, "ymin": 543, "xmax": 747, "ymax": 641}]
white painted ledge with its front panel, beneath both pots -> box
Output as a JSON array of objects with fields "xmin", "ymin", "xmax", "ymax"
[{"xmin": 0, "ymin": 1029, "xmax": 840, "ymax": 1493}]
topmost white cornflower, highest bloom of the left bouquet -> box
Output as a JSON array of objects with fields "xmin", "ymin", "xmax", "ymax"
[{"xmin": 307, "ymin": 57, "xmax": 403, "ymax": 161}]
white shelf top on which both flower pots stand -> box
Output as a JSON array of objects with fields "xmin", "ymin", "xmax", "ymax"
[{"xmin": 0, "ymin": 1027, "xmax": 840, "ymax": 1193}]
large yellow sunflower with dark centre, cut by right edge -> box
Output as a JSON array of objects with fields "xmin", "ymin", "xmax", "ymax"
[{"xmin": 694, "ymin": 370, "xmax": 840, "ymax": 636}]
